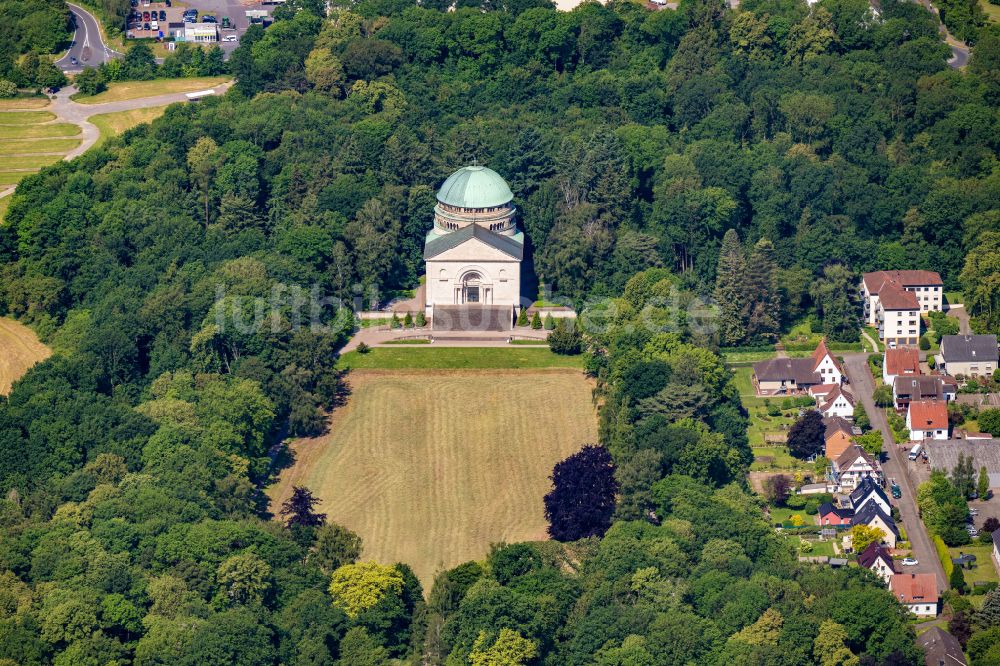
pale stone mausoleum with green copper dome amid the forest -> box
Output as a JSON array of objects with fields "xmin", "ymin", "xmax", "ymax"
[{"xmin": 424, "ymin": 166, "xmax": 524, "ymax": 330}]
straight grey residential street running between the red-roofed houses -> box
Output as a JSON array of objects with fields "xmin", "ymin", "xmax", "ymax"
[{"xmin": 844, "ymin": 354, "xmax": 948, "ymax": 590}]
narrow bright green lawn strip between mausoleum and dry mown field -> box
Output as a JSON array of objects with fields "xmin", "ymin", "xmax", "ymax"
[{"xmin": 338, "ymin": 345, "xmax": 583, "ymax": 370}]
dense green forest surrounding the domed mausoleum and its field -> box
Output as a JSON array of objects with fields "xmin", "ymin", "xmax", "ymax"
[{"xmin": 0, "ymin": 0, "xmax": 1000, "ymax": 666}]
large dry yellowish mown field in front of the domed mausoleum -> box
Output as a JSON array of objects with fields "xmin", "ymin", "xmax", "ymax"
[{"xmin": 268, "ymin": 366, "xmax": 597, "ymax": 590}]
